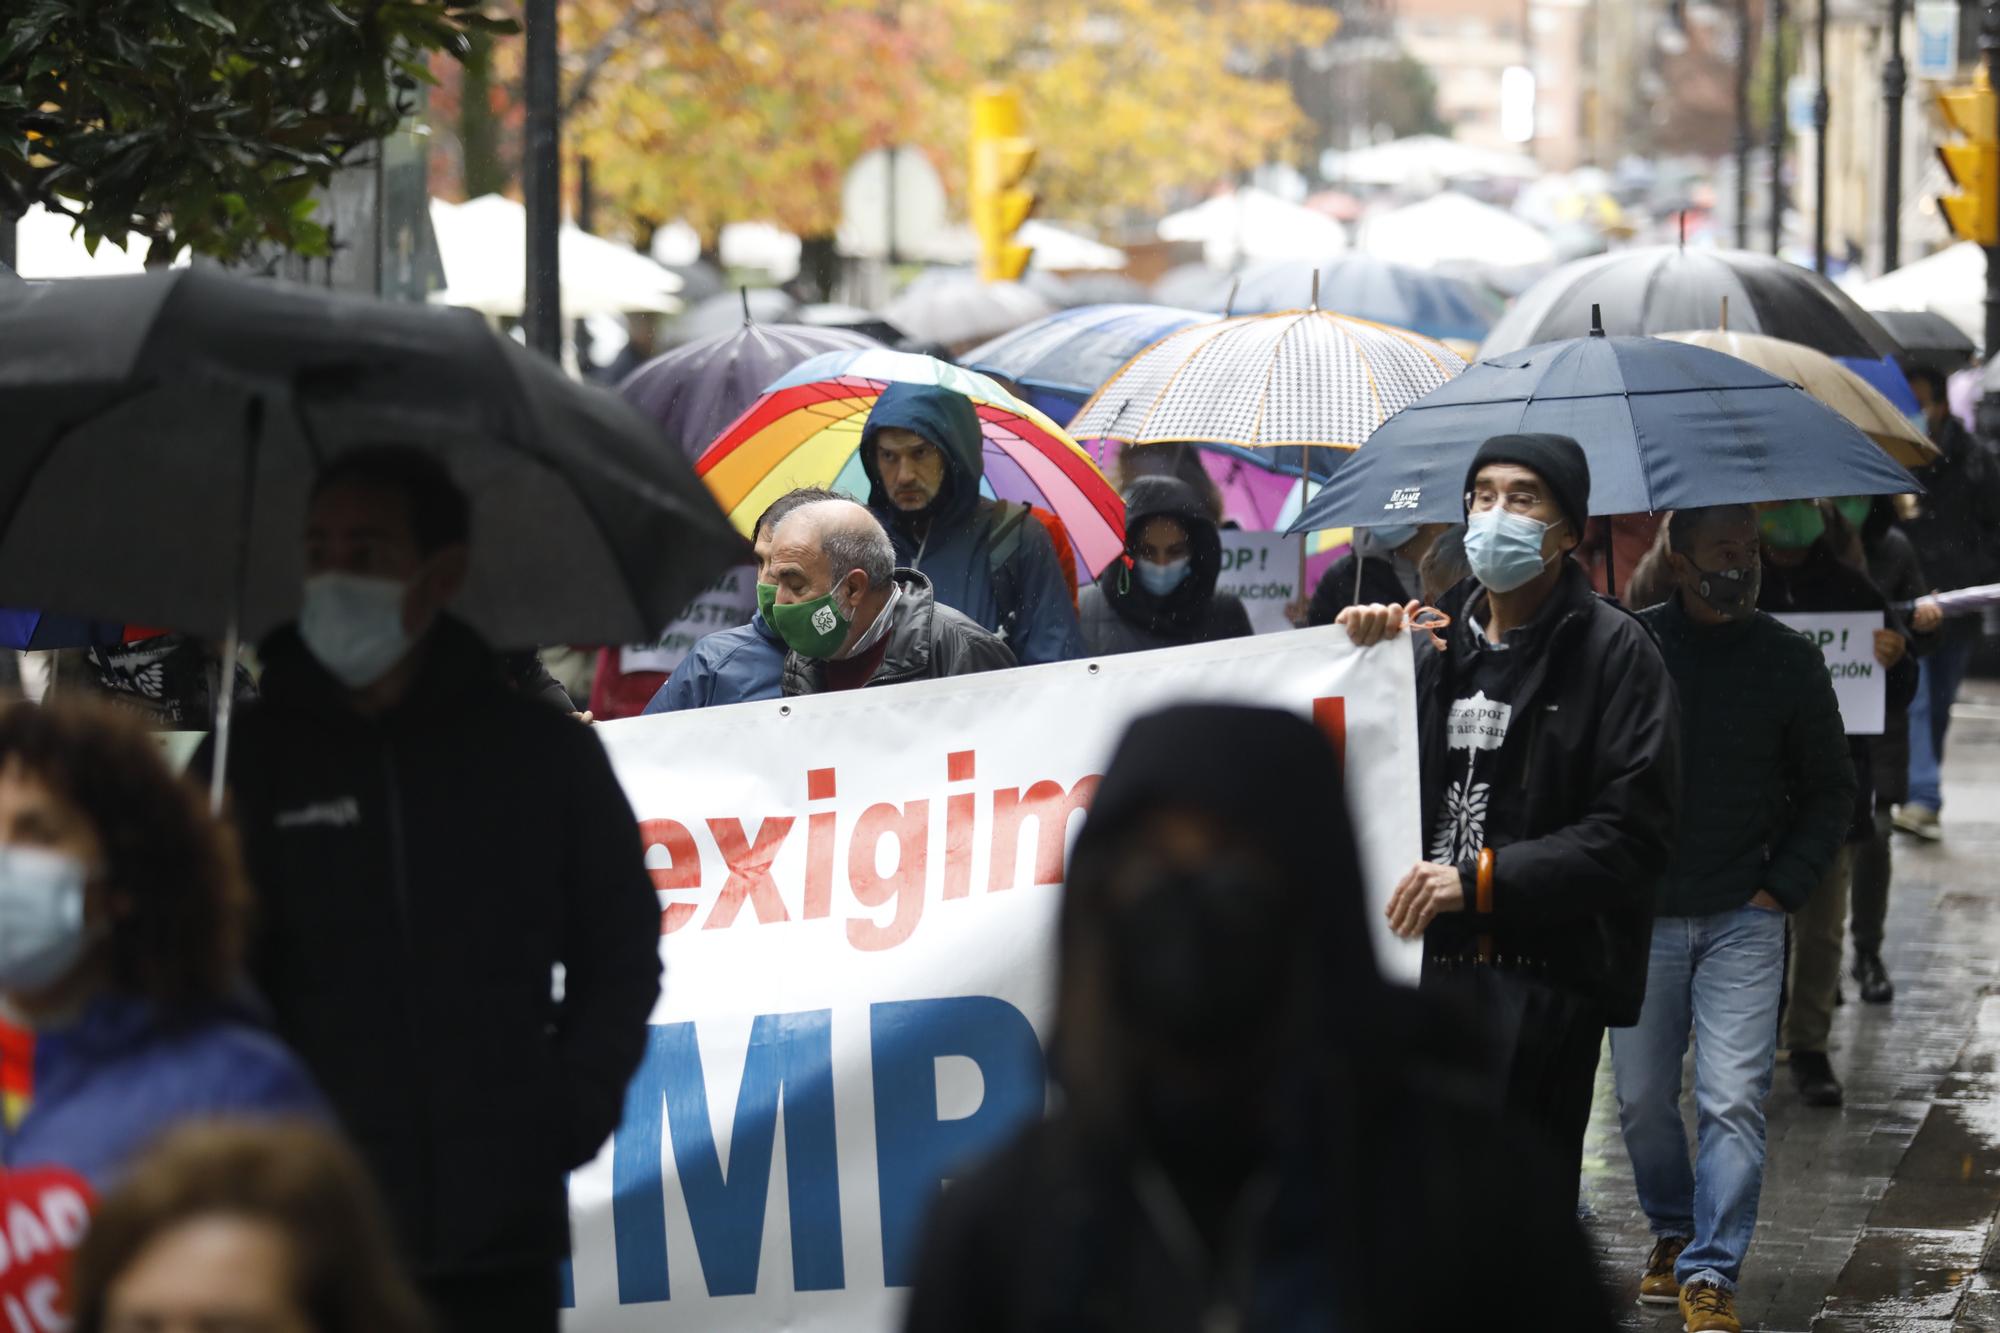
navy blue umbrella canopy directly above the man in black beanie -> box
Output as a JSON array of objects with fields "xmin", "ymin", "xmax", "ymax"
[{"xmin": 1292, "ymin": 334, "xmax": 1922, "ymax": 530}]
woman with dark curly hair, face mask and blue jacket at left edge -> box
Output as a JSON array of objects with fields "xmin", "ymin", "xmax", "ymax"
[{"xmin": 0, "ymin": 703, "xmax": 324, "ymax": 1189}]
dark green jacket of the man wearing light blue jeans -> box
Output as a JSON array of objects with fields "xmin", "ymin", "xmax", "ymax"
[{"xmin": 1640, "ymin": 594, "xmax": 1854, "ymax": 917}]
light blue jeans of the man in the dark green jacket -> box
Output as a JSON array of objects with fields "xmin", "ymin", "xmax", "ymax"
[{"xmin": 1612, "ymin": 907, "xmax": 1784, "ymax": 1291}]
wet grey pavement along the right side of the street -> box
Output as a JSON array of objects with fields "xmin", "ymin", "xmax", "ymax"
[{"xmin": 1584, "ymin": 681, "xmax": 2000, "ymax": 1333}]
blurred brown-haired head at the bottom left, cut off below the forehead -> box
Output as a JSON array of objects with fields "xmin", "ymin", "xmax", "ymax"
[{"xmin": 72, "ymin": 1121, "xmax": 428, "ymax": 1333}]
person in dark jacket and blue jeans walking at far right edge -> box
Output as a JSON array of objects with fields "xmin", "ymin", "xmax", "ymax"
[{"xmin": 1894, "ymin": 366, "xmax": 2000, "ymax": 841}]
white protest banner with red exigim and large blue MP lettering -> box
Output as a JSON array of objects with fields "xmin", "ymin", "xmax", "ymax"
[{"xmin": 564, "ymin": 628, "xmax": 1420, "ymax": 1333}]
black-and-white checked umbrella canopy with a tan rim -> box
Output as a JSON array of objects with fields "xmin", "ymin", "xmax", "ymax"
[{"xmin": 1070, "ymin": 310, "xmax": 1466, "ymax": 474}]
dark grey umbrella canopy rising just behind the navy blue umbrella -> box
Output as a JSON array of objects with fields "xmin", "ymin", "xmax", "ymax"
[{"xmin": 1480, "ymin": 246, "xmax": 1902, "ymax": 356}]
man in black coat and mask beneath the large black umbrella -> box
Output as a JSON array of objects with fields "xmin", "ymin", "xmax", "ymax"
[{"xmin": 194, "ymin": 446, "xmax": 660, "ymax": 1333}]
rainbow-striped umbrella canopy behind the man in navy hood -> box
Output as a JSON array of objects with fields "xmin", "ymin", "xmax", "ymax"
[{"xmin": 694, "ymin": 348, "xmax": 1124, "ymax": 576}]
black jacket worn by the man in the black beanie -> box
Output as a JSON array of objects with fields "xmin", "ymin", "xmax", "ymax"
[{"xmin": 1416, "ymin": 562, "xmax": 1680, "ymax": 1027}]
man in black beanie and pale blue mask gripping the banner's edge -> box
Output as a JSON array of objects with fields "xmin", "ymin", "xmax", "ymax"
[{"xmin": 1338, "ymin": 434, "xmax": 1680, "ymax": 1197}]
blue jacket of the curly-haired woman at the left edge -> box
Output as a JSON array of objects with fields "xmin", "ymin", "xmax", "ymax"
[{"xmin": 0, "ymin": 995, "xmax": 328, "ymax": 1191}]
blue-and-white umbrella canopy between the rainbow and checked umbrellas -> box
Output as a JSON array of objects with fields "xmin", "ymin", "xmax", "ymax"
[{"xmin": 958, "ymin": 304, "xmax": 1210, "ymax": 422}]
